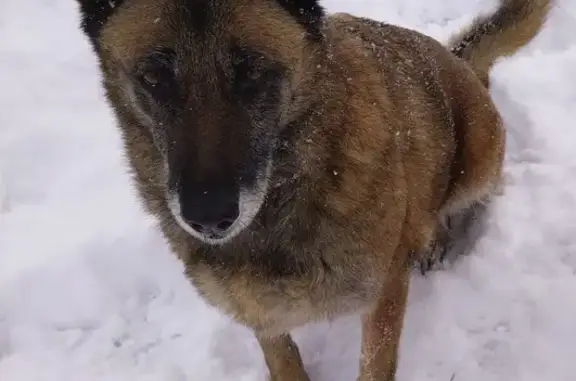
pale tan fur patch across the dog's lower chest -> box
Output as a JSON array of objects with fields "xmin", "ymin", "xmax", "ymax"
[{"xmin": 190, "ymin": 243, "xmax": 385, "ymax": 335}]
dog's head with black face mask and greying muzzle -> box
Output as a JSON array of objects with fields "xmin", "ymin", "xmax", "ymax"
[{"xmin": 79, "ymin": 0, "xmax": 323, "ymax": 244}]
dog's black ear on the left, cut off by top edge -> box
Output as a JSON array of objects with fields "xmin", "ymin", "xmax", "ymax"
[{"xmin": 77, "ymin": 0, "xmax": 124, "ymax": 48}]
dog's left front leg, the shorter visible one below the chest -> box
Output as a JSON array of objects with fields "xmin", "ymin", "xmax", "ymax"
[{"xmin": 256, "ymin": 334, "xmax": 310, "ymax": 381}]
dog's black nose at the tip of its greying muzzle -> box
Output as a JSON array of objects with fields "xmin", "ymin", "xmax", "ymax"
[{"xmin": 179, "ymin": 183, "xmax": 239, "ymax": 238}]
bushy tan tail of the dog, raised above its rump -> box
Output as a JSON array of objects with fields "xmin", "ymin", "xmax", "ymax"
[{"xmin": 448, "ymin": 0, "xmax": 552, "ymax": 87}]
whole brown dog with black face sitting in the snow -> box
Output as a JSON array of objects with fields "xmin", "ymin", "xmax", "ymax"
[{"xmin": 74, "ymin": 0, "xmax": 550, "ymax": 381}]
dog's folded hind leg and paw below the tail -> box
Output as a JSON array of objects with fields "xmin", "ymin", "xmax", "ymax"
[{"xmin": 416, "ymin": 68, "xmax": 506, "ymax": 272}]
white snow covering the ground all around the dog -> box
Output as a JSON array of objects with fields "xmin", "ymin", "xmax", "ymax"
[{"xmin": 0, "ymin": 0, "xmax": 576, "ymax": 381}]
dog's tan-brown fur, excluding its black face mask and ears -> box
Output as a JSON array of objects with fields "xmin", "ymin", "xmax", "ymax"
[{"xmin": 84, "ymin": 0, "xmax": 548, "ymax": 381}]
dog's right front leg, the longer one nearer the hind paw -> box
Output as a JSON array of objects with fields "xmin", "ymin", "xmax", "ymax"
[{"xmin": 358, "ymin": 256, "xmax": 410, "ymax": 381}]
